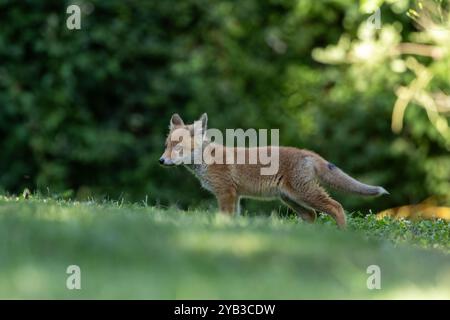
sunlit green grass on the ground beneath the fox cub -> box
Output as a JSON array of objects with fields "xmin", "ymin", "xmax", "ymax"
[{"xmin": 0, "ymin": 197, "xmax": 450, "ymax": 299}]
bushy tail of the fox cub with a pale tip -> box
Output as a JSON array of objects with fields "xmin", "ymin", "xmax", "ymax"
[{"xmin": 315, "ymin": 157, "xmax": 389, "ymax": 196}]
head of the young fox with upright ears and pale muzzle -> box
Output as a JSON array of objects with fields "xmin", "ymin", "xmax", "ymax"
[{"xmin": 159, "ymin": 113, "xmax": 208, "ymax": 166}]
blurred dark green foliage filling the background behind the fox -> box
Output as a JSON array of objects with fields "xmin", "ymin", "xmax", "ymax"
[{"xmin": 0, "ymin": 0, "xmax": 450, "ymax": 210}]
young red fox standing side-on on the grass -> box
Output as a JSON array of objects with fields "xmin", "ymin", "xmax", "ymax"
[{"xmin": 159, "ymin": 113, "xmax": 389, "ymax": 228}]
